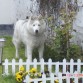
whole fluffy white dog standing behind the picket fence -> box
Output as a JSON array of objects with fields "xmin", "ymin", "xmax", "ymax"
[{"xmin": 13, "ymin": 16, "xmax": 46, "ymax": 61}]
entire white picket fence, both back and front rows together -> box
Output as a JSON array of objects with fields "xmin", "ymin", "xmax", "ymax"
[{"xmin": 2, "ymin": 59, "xmax": 83, "ymax": 83}]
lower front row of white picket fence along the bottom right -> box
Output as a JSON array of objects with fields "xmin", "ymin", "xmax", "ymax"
[{"xmin": 24, "ymin": 72, "xmax": 83, "ymax": 83}]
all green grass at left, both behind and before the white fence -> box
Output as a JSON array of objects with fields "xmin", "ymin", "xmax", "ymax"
[{"xmin": 0, "ymin": 36, "xmax": 26, "ymax": 83}]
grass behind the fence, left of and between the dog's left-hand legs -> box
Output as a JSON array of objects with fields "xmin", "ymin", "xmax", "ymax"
[{"xmin": 3, "ymin": 36, "xmax": 25, "ymax": 61}]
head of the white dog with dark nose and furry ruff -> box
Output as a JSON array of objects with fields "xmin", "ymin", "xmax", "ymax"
[{"xmin": 27, "ymin": 15, "xmax": 46, "ymax": 35}]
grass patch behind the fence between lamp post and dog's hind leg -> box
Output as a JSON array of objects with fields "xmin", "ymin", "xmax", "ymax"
[{"xmin": 3, "ymin": 37, "xmax": 15, "ymax": 61}]
